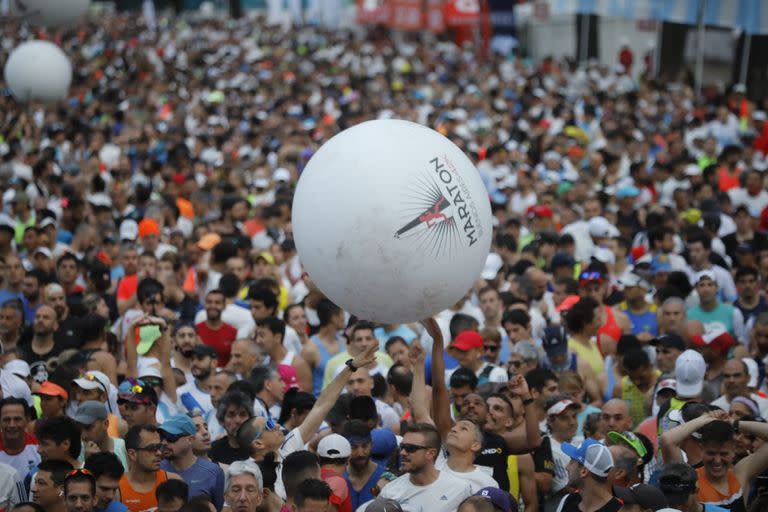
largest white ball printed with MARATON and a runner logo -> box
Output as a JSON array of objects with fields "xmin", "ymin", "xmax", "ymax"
[{"xmin": 293, "ymin": 120, "xmax": 492, "ymax": 323}]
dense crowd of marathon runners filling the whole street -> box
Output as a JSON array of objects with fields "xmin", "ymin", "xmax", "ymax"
[{"xmin": 0, "ymin": 5, "xmax": 768, "ymax": 512}]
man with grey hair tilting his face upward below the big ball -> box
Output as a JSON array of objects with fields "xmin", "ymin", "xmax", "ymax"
[{"xmin": 435, "ymin": 419, "xmax": 499, "ymax": 494}]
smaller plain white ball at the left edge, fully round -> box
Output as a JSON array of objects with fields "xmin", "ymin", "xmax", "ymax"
[{"xmin": 4, "ymin": 41, "xmax": 72, "ymax": 102}]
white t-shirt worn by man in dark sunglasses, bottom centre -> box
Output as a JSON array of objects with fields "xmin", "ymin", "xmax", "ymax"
[{"xmin": 358, "ymin": 471, "xmax": 472, "ymax": 512}]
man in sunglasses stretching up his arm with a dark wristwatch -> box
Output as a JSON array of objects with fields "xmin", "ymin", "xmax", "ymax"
[{"xmin": 237, "ymin": 343, "xmax": 376, "ymax": 498}]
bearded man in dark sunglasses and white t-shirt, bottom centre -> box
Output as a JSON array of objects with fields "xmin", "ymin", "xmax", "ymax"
[{"xmin": 372, "ymin": 423, "xmax": 472, "ymax": 512}]
